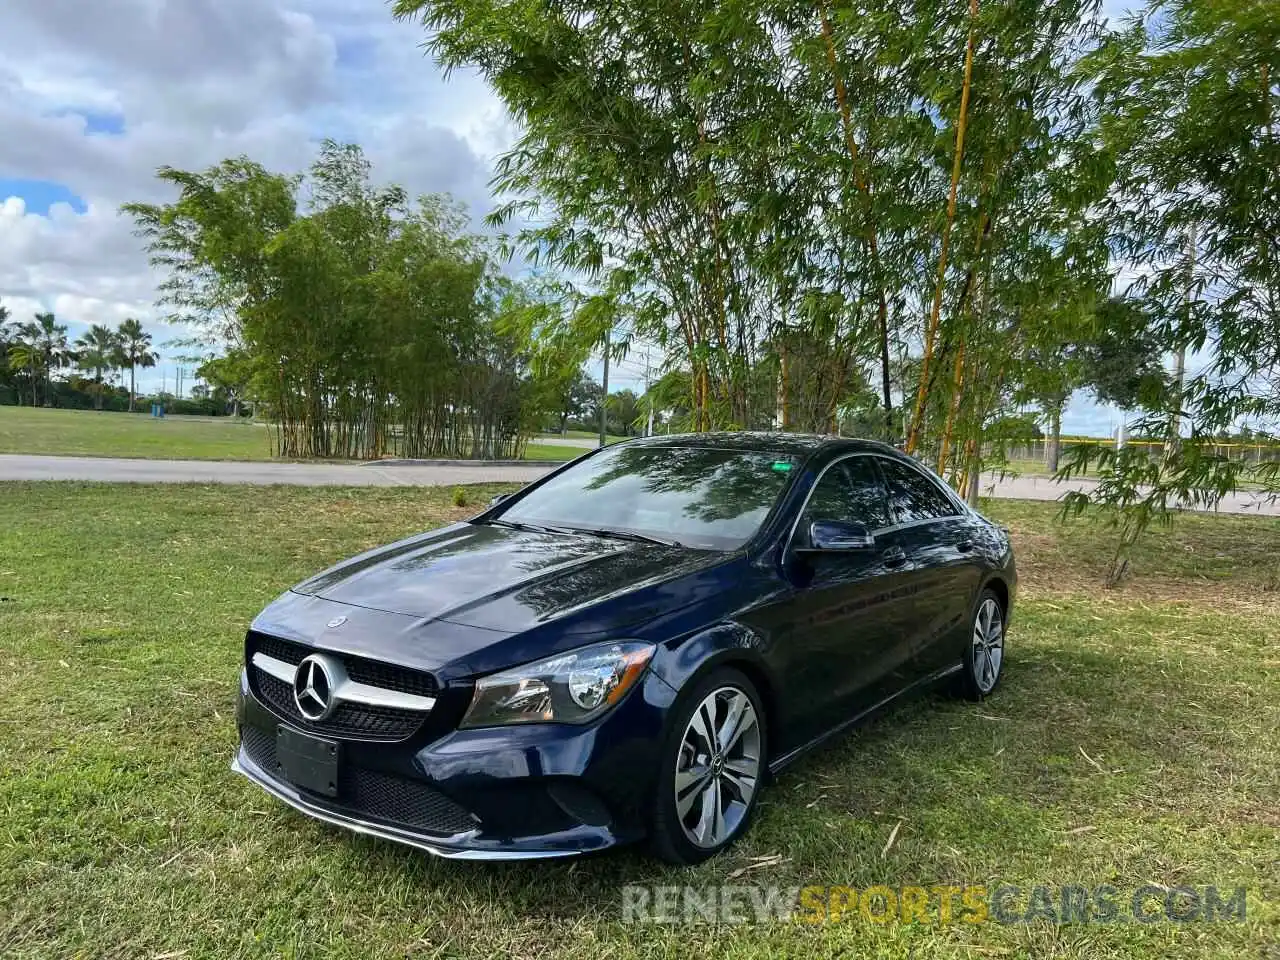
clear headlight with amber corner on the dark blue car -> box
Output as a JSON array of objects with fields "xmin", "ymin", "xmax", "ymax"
[{"xmin": 461, "ymin": 640, "xmax": 654, "ymax": 727}]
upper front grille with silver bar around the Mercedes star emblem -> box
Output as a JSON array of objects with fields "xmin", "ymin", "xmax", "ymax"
[{"xmin": 247, "ymin": 632, "xmax": 439, "ymax": 740}]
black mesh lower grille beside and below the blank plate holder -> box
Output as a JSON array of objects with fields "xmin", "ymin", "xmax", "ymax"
[{"xmin": 241, "ymin": 726, "xmax": 476, "ymax": 837}]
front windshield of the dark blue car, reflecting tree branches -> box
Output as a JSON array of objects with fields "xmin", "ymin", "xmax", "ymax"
[{"xmin": 499, "ymin": 444, "xmax": 795, "ymax": 550}]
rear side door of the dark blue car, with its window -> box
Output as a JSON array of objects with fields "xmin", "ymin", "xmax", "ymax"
[{"xmin": 876, "ymin": 457, "xmax": 980, "ymax": 676}]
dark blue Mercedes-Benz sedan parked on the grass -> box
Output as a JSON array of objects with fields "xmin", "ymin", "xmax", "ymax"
[{"xmin": 233, "ymin": 434, "xmax": 1015, "ymax": 863}]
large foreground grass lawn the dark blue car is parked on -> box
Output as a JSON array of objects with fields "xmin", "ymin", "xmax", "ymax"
[{"xmin": 0, "ymin": 484, "xmax": 1280, "ymax": 960}]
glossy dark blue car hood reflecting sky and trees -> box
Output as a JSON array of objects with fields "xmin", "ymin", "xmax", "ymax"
[{"xmin": 294, "ymin": 524, "xmax": 724, "ymax": 635}]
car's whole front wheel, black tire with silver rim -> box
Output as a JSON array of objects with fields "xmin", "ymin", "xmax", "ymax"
[{"xmin": 649, "ymin": 667, "xmax": 768, "ymax": 865}]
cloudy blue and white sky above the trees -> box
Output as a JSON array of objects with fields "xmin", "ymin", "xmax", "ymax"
[{"xmin": 0, "ymin": 0, "xmax": 1123, "ymax": 434}]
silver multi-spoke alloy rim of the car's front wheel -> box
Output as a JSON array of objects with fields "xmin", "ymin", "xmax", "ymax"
[{"xmin": 675, "ymin": 686, "xmax": 763, "ymax": 850}]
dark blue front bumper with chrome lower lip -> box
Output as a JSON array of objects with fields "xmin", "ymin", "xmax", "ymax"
[{"xmin": 232, "ymin": 673, "xmax": 675, "ymax": 860}]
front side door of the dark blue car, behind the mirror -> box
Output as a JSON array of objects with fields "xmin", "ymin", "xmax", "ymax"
[{"xmin": 768, "ymin": 453, "xmax": 913, "ymax": 736}]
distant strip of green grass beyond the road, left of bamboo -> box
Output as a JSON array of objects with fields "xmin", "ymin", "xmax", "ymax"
[{"xmin": 0, "ymin": 406, "xmax": 271, "ymax": 460}]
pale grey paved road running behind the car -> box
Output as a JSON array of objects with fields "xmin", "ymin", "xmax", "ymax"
[{"xmin": 0, "ymin": 454, "xmax": 1280, "ymax": 516}]
